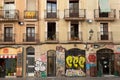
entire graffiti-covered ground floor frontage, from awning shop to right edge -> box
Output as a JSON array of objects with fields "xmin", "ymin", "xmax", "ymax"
[{"xmin": 0, "ymin": 44, "xmax": 120, "ymax": 77}]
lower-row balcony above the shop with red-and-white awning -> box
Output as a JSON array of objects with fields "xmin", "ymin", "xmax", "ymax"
[{"xmin": 0, "ymin": 33, "xmax": 15, "ymax": 44}]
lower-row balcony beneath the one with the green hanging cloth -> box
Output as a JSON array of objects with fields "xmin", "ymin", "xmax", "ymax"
[{"xmin": 97, "ymin": 31, "xmax": 113, "ymax": 42}]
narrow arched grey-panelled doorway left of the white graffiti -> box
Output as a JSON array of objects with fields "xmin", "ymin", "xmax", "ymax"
[{"xmin": 26, "ymin": 47, "xmax": 35, "ymax": 76}]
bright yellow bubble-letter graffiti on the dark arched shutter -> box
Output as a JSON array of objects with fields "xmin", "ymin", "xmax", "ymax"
[{"xmin": 66, "ymin": 56, "xmax": 85, "ymax": 68}]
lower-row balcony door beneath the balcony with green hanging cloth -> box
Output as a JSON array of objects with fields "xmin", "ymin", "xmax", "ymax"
[{"xmin": 100, "ymin": 23, "xmax": 109, "ymax": 40}]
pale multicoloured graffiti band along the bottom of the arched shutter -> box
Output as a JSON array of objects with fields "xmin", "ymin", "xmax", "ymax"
[{"xmin": 66, "ymin": 69, "xmax": 85, "ymax": 76}]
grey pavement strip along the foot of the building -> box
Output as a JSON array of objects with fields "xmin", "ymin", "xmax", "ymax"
[{"xmin": 0, "ymin": 77, "xmax": 120, "ymax": 80}]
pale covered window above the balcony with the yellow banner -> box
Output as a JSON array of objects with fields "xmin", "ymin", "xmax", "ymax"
[{"xmin": 26, "ymin": 0, "xmax": 36, "ymax": 11}]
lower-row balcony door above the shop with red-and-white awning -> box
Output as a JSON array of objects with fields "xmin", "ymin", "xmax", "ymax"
[{"xmin": 4, "ymin": 27, "xmax": 13, "ymax": 42}]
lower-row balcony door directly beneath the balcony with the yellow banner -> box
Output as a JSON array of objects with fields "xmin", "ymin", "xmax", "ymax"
[{"xmin": 26, "ymin": 27, "xmax": 35, "ymax": 42}]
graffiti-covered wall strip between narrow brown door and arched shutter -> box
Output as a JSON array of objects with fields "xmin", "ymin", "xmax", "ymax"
[{"xmin": 56, "ymin": 46, "xmax": 65, "ymax": 76}]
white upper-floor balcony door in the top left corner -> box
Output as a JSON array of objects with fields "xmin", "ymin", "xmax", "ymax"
[{"xmin": 4, "ymin": 0, "xmax": 15, "ymax": 18}]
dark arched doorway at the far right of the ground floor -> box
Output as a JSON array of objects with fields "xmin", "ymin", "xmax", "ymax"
[{"xmin": 97, "ymin": 48, "xmax": 114, "ymax": 75}]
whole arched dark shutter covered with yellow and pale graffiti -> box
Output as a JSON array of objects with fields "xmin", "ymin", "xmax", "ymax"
[{"xmin": 65, "ymin": 48, "xmax": 86, "ymax": 76}]
